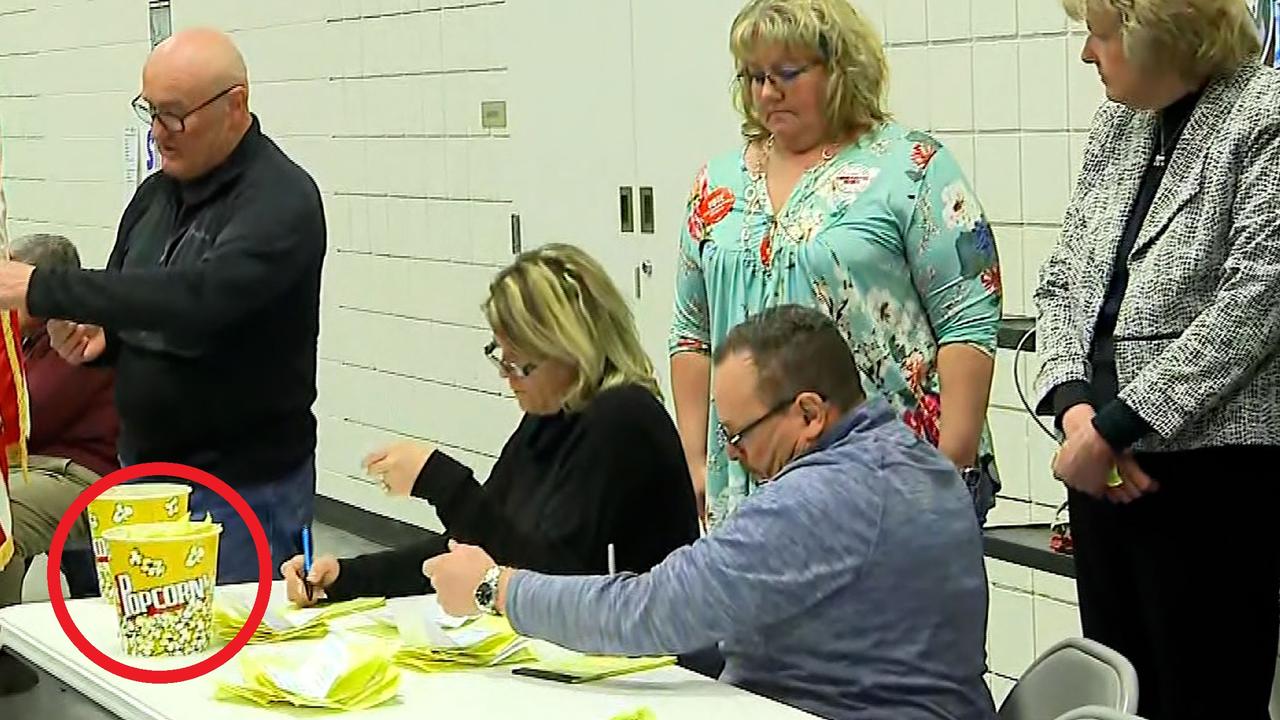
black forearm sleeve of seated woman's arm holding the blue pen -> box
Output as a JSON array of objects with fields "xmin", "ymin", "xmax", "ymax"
[{"xmin": 325, "ymin": 530, "xmax": 448, "ymax": 601}]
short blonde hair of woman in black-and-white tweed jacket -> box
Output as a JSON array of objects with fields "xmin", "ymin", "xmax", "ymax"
[{"xmin": 1062, "ymin": 0, "xmax": 1262, "ymax": 81}]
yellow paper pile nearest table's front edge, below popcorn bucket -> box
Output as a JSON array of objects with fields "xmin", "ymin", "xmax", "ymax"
[{"xmin": 214, "ymin": 635, "xmax": 399, "ymax": 710}]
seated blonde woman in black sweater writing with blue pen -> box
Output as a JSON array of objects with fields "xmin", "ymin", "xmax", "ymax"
[{"xmin": 282, "ymin": 245, "xmax": 698, "ymax": 605}]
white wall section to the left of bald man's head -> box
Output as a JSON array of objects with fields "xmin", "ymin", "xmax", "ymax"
[{"xmin": 0, "ymin": 0, "xmax": 148, "ymax": 265}]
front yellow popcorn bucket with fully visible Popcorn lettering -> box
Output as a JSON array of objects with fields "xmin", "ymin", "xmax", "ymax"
[{"xmin": 102, "ymin": 518, "xmax": 223, "ymax": 657}]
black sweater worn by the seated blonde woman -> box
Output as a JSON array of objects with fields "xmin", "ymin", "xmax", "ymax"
[{"xmin": 328, "ymin": 387, "xmax": 698, "ymax": 601}]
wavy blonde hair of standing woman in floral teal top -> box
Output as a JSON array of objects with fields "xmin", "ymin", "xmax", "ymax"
[{"xmin": 730, "ymin": 0, "xmax": 888, "ymax": 140}]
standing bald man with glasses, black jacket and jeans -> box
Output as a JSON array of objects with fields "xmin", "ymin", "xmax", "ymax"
[{"xmin": 0, "ymin": 29, "xmax": 325, "ymax": 583}]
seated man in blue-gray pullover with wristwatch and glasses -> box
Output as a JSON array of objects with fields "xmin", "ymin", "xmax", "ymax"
[{"xmin": 424, "ymin": 305, "xmax": 995, "ymax": 720}]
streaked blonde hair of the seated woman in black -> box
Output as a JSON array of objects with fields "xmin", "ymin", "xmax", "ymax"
[{"xmin": 483, "ymin": 245, "xmax": 662, "ymax": 411}]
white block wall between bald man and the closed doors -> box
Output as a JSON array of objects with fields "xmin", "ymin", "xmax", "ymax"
[{"xmin": 165, "ymin": 0, "xmax": 518, "ymax": 527}]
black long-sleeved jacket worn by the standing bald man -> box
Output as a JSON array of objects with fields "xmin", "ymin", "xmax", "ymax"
[{"xmin": 27, "ymin": 118, "xmax": 325, "ymax": 484}]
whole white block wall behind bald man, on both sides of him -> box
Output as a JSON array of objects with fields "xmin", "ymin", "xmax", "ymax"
[{"xmin": 0, "ymin": 0, "xmax": 518, "ymax": 525}]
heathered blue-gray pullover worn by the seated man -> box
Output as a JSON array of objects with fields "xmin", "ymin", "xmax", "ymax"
[{"xmin": 507, "ymin": 401, "xmax": 995, "ymax": 720}]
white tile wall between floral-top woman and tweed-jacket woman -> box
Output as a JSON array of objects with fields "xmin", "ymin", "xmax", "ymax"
[{"xmin": 854, "ymin": 0, "xmax": 1103, "ymax": 702}]
